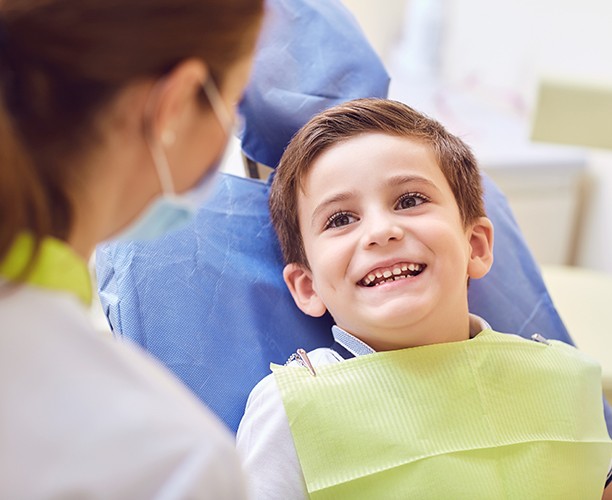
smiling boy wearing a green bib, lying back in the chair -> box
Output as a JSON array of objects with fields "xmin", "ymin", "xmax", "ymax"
[{"xmin": 237, "ymin": 99, "xmax": 610, "ymax": 499}]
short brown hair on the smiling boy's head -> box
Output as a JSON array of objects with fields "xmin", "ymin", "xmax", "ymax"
[{"xmin": 270, "ymin": 98, "xmax": 485, "ymax": 267}]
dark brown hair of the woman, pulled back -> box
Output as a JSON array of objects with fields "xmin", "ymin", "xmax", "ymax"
[{"xmin": 0, "ymin": 0, "xmax": 263, "ymax": 262}]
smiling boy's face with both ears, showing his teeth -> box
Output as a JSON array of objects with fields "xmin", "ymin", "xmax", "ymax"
[{"xmin": 284, "ymin": 133, "xmax": 493, "ymax": 350}]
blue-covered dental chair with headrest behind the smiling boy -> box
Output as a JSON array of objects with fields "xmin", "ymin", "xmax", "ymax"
[{"xmin": 96, "ymin": 0, "xmax": 612, "ymax": 432}]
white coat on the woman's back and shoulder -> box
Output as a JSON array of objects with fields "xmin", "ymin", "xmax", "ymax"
[{"xmin": 0, "ymin": 285, "xmax": 249, "ymax": 500}]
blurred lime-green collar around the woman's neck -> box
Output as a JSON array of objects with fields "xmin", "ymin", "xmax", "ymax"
[{"xmin": 0, "ymin": 234, "xmax": 92, "ymax": 306}]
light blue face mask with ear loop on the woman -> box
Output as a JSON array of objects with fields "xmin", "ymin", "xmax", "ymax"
[{"xmin": 112, "ymin": 78, "xmax": 232, "ymax": 241}]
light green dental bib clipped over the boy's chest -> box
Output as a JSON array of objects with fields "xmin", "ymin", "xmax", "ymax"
[{"xmin": 272, "ymin": 330, "xmax": 612, "ymax": 500}]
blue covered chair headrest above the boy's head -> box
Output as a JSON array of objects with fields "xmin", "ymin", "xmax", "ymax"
[{"xmin": 239, "ymin": 0, "xmax": 389, "ymax": 167}]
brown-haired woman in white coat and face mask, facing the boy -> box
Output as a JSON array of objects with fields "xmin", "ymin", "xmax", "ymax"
[{"xmin": 0, "ymin": 0, "xmax": 263, "ymax": 499}]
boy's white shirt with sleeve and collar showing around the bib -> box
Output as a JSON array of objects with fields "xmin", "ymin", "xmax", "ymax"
[{"xmin": 236, "ymin": 314, "xmax": 490, "ymax": 500}]
